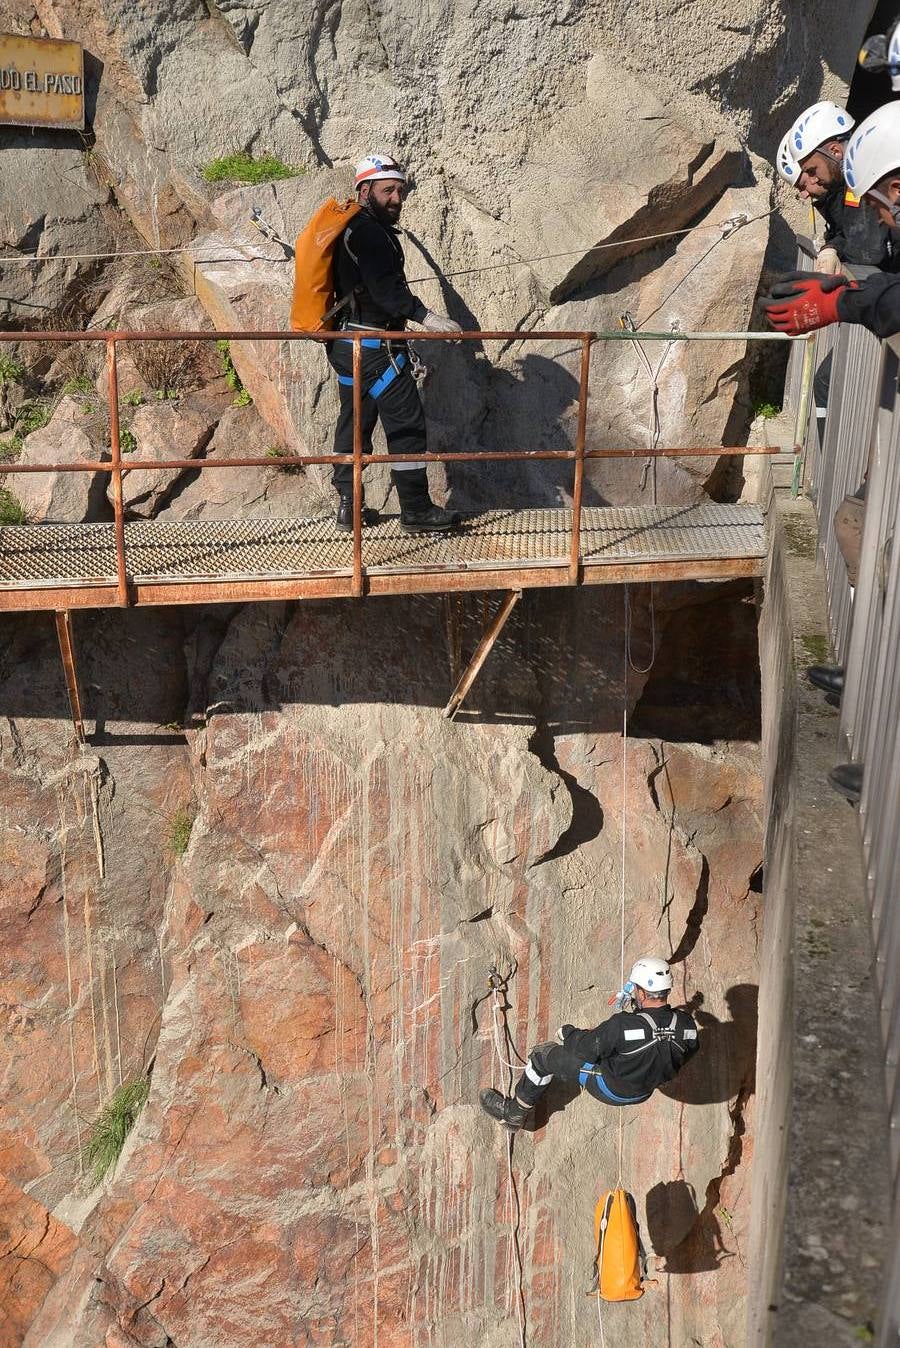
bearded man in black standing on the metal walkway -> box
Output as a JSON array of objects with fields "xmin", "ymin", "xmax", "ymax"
[{"xmin": 329, "ymin": 154, "xmax": 461, "ymax": 534}]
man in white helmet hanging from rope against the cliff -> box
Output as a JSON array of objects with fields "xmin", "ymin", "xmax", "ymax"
[{"xmin": 480, "ymin": 956, "xmax": 699, "ymax": 1132}]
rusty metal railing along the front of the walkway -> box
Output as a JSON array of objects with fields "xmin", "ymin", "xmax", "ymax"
[{"xmin": 0, "ymin": 329, "xmax": 796, "ymax": 607}]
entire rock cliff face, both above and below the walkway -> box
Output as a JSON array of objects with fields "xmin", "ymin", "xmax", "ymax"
[{"xmin": 0, "ymin": 0, "xmax": 868, "ymax": 1348}]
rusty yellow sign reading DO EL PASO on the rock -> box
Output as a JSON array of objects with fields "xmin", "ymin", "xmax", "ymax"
[{"xmin": 0, "ymin": 32, "xmax": 85, "ymax": 131}]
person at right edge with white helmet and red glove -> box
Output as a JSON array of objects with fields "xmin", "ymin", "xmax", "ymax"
[{"xmin": 763, "ymin": 101, "xmax": 900, "ymax": 337}]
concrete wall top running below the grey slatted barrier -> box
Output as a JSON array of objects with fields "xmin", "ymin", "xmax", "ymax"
[{"xmin": 748, "ymin": 465, "xmax": 891, "ymax": 1348}]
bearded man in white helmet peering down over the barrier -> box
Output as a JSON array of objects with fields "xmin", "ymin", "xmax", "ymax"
[{"xmin": 775, "ymin": 102, "xmax": 888, "ymax": 275}]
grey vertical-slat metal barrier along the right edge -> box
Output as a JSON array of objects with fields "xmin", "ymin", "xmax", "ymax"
[{"xmin": 786, "ymin": 268, "xmax": 900, "ymax": 1348}]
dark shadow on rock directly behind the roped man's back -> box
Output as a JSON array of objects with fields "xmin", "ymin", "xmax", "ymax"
[{"xmin": 660, "ymin": 983, "xmax": 759, "ymax": 1104}]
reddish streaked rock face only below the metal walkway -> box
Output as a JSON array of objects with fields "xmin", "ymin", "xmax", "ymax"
[{"xmin": 0, "ymin": 588, "xmax": 761, "ymax": 1348}]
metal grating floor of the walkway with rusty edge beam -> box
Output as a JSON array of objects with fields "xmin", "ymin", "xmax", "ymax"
[{"xmin": 0, "ymin": 501, "xmax": 765, "ymax": 609}]
